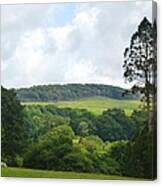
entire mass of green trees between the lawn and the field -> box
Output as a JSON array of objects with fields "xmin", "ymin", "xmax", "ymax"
[{"xmin": 2, "ymin": 88, "xmax": 153, "ymax": 178}]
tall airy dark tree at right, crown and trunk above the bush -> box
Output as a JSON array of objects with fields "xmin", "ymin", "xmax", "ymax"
[{"xmin": 123, "ymin": 17, "xmax": 157, "ymax": 129}]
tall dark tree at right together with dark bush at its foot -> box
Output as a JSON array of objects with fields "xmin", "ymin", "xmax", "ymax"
[{"xmin": 123, "ymin": 18, "xmax": 157, "ymax": 179}]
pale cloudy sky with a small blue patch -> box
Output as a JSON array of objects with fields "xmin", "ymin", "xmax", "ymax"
[{"xmin": 1, "ymin": 1, "xmax": 152, "ymax": 88}]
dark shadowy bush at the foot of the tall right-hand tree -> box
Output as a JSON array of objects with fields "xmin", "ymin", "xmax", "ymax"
[{"xmin": 126, "ymin": 128, "xmax": 156, "ymax": 179}]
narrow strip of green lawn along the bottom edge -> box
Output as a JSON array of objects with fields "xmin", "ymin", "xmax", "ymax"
[{"xmin": 1, "ymin": 168, "xmax": 142, "ymax": 180}]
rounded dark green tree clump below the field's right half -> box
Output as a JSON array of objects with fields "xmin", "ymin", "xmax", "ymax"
[{"xmin": 96, "ymin": 109, "xmax": 139, "ymax": 141}]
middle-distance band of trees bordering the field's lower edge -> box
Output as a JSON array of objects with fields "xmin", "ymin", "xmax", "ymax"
[{"xmin": 25, "ymin": 105, "xmax": 144, "ymax": 141}]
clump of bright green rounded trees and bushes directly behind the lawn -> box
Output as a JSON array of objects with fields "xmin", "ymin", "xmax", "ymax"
[{"xmin": 24, "ymin": 125, "xmax": 119, "ymax": 174}]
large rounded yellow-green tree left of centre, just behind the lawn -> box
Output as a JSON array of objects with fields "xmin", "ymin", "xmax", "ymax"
[{"xmin": 24, "ymin": 125, "xmax": 74, "ymax": 170}]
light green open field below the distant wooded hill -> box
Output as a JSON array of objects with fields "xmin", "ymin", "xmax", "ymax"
[{"xmin": 23, "ymin": 97, "xmax": 140, "ymax": 115}]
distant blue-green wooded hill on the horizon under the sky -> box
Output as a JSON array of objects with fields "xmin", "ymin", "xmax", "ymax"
[{"xmin": 16, "ymin": 84, "xmax": 137, "ymax": 102}]
